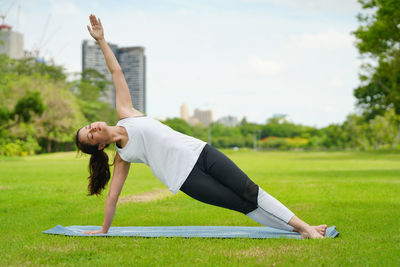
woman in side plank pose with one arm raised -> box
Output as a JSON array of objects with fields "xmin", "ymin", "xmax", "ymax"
[{"xmin": 76, "ymin": 15, "xmax": 327, "ymax": 238}]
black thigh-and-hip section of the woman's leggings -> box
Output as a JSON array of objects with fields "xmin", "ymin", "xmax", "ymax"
[{"xmin": 180, "ymin": 145, "xmax": 258, "ymax": 214}]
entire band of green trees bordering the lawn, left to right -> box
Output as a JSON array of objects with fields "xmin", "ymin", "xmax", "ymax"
[{"xmin": 0, "ymin": 0, "xmax": 400, "ymax": 155}]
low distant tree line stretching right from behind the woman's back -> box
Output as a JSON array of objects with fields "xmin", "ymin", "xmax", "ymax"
[{"xmin": 164, "ymin": 109, "xmax": 400, "ymax": 150}]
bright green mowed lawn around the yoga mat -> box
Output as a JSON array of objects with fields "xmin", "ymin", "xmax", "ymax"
[{"xmin": 0, "ymin": 151, "xmax": 400, "ymax": 266}]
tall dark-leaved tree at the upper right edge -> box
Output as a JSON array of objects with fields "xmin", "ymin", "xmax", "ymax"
[{"xmin": 354, "ymin": 0, "xmax": 400, "ymax": 120}]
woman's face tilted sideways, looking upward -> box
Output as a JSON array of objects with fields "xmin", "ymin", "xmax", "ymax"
[{"xmin": 79, "ymin": 121, "xmax": 108, "ymax": 145}]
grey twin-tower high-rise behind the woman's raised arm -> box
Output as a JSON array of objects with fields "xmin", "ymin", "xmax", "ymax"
[{"xmin": 82, "ymin": 40, "xmax": 146, "ymax": 112}]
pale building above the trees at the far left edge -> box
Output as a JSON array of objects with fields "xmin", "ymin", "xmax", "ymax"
[{"xmin": 0, "ymin": 24, "xmax": 24, "ymax": 59}]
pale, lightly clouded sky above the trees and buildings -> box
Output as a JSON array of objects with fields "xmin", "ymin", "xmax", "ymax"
[{"xmin": 0, "ymin": 0, "xmax": 361, "ymax": 127}]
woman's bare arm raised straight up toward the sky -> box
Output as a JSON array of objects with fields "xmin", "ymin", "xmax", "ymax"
[{"xmin": 87, "ymin": 15, "xmax": 143, "ymax": 118}]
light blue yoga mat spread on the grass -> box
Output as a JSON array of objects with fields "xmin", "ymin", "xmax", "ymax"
[{"xmin": 43, "ymin": 225, "xmax": 339, "ymax": 239}]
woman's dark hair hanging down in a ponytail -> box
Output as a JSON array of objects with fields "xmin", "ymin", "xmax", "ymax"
[{"xmin": 75, "ymin": 129, "xmax": 110, "ymax": 196}]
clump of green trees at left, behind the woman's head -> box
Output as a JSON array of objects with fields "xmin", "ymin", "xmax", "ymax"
[{"xmin": 0, "ymin": 54, "xmax": 118, "ymax": 155}]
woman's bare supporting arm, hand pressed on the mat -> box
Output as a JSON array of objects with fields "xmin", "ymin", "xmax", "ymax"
[{"xmin": 84, "ymin": 153, "xmax": 131, "ymax": 234}]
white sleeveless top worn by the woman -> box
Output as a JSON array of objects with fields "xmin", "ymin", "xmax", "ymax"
[{"xmin": 117, "ymin": 116, "xmax": 206, "ymax": 194}]
